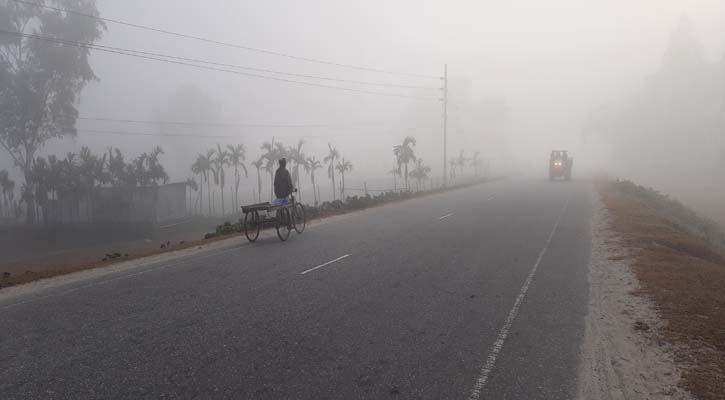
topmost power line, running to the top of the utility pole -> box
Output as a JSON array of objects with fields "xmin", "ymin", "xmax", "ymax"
[{"xmin": 12, "ymin": 0, "xmax": 440, "ymax": 79}]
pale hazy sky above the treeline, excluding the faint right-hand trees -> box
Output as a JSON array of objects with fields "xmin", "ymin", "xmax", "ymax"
[{"xmin": 2, "ymin": 0, "xmax": 725, "ymax": 192}]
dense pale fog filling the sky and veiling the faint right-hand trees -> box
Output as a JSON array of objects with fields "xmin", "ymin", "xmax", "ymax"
[{"xmin": 0, "ymin": 0, "xmax": 725, "ymax": 222}]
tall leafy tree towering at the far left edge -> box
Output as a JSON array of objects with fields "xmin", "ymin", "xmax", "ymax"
[{"xmin": 0, "ymin": 1, "xmax": 105, "ymax": 223}]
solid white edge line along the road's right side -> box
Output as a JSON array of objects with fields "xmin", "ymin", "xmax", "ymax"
[{"xmin": 468, "ymin": 198, "xmax": 569, "ymax": 400}]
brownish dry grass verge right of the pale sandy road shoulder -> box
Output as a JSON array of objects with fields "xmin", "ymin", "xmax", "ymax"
[{"xmin": 595, "ymin": 179, "xmax": 725, "ymax": 400}]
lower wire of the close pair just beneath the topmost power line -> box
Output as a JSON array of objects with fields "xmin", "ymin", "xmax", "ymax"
[{"xmin": 0, "ymin": 29, "xmax": 439, "ymax": 100}]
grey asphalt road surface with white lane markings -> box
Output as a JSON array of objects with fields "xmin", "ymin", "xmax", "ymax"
[{"xmin": 0, "ymin": 178, "xmax": 592, "ymax": 400}]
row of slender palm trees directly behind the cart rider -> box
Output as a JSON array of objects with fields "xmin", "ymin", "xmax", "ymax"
[{"xmin": 187, "ymin": 139, "xmax": 353, "ymax": 215}]
